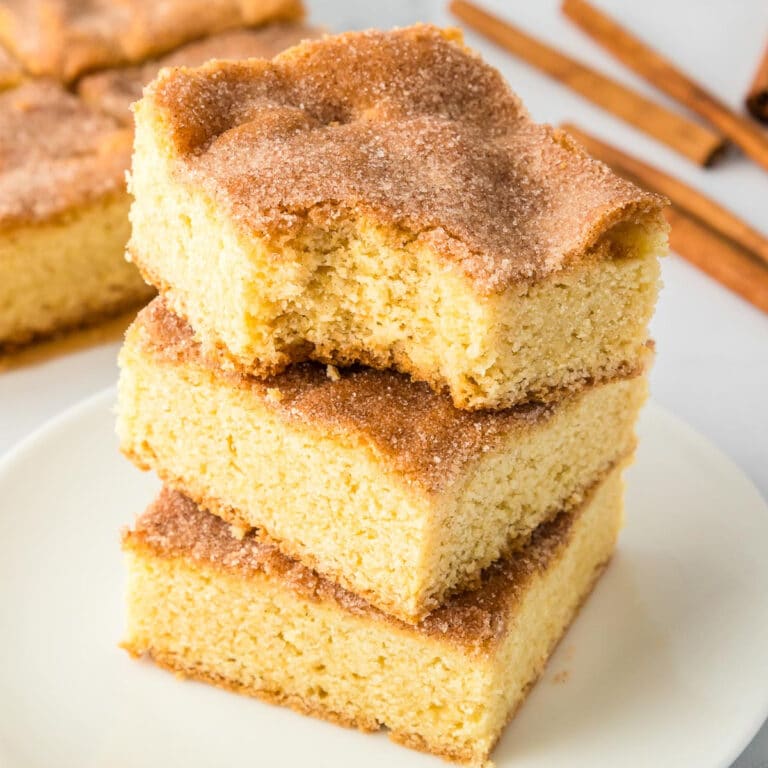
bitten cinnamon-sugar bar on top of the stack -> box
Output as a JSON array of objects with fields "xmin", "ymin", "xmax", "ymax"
[{"xmin": 130, "ymin": 26, "xmax": 666, "ymax": 409}]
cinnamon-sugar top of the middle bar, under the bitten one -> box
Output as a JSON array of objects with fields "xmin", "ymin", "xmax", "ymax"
[{"xmin": 128, "ymin": 297, "xmax": 592, "ymax": 493}]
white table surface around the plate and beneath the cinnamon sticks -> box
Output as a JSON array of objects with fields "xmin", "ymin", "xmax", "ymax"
[{"xmin": 0, "ymin": 0, "xmax": 768, "ymax": 768}]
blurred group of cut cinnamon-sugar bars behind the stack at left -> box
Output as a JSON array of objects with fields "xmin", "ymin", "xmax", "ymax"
[{"xmin": 0, "ymin": 0, "xmax": 317, "ymax": 353}]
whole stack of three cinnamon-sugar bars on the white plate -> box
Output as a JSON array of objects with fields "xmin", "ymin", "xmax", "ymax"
[{"xmin": 118, "ymin": 26, "xmax": 666, "ymax": 764}]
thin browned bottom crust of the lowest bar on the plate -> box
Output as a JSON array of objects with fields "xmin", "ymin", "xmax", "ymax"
[{"xmin": 122, "ymin": 544, "xmax": 608, "ymax": 765}]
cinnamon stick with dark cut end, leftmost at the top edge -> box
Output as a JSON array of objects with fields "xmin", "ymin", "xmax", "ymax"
[{"xmin": 449, "ymin": 0, "xmax": 725, "ymax": 166}]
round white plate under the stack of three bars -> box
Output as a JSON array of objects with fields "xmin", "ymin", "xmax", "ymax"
[{"xmin": 0, "ymin": 390, "xmax": 768, "ymax": 768}]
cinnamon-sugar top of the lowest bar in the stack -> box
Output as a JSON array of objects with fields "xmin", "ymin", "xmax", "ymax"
[{"xmin": 123, "ymin": 488, "xmax": 604, "ymax": 653}]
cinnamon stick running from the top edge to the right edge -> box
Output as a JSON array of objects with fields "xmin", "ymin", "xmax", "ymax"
[{"xmin": 562, "ymin": 0, "xmax": 768, "ymax": 169}]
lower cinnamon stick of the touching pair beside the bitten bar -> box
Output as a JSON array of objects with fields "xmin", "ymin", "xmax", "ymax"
[{"xmin": 666, "ymin": 208, "xmax": 768, "ymax": 312}]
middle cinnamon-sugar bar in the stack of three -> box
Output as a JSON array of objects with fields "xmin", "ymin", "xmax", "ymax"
[{"xmin": 118, "ymin": 300, "xmax": 646, "ymax": 622}]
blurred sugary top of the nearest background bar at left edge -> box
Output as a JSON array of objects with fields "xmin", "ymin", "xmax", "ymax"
[{"xmin": 0, "ymin": 80, "xmax": 131, "ymax": 230}]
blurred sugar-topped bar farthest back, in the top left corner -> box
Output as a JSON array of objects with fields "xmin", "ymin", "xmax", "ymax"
[{"xmin": 0, "ymin": 0, "xmax": 303, "ymax": 82}]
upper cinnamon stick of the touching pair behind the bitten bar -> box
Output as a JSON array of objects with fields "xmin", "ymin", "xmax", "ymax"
[{"xmin": 563, "ymin": 123, "xmax": 768, "ymax": 267}]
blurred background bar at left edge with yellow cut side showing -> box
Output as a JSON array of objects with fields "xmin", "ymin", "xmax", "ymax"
[{"xmin": 0, "ymin": 81, "xmax": 153, "ymax": 350}]
